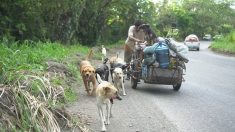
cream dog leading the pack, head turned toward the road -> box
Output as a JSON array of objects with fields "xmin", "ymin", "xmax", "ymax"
[{"xmin": 96, "ymin": 74, "xmax": 122, "ymax": 131}]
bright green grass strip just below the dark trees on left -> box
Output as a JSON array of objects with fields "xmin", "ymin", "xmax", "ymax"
[{"xmin": 0, "ymin": 41, "xmax": 88, "ymax": 81}]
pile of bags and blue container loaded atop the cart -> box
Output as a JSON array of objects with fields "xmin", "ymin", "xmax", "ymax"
[{"xmin": 142, "ymin": 39, "xmax": 189, "ymax": 76}]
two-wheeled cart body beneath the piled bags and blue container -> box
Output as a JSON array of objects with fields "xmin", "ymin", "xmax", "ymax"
[{"xmin": 130, "ymin": 39, "xmax": 186, "ymax": 91}]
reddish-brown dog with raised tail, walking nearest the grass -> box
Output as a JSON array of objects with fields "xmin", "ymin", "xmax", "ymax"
[{"xmin": 80, "ymin": 50, "xmax": 97, "ymax": 95}]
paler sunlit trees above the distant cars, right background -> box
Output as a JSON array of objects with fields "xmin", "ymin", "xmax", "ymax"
[{"xmin": 157, "ymin": 0, "xmax": 235, "ymax": 38}]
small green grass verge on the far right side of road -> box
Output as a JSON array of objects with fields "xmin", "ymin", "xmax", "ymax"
[{"xmin": 211, "ymin": 31, "xmax": 235, "ymax": 54}]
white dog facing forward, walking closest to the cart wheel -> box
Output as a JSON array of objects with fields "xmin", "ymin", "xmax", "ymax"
[{"xmin": 112, "ymin": 67, "xmax": 126, "ymax": 95}]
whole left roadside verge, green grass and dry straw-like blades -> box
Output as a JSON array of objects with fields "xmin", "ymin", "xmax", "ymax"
[{"xmin": 0, "ymin": 41, "xmax": 94, "ymax": 131}]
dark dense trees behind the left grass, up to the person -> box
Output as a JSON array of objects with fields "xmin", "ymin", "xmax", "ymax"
[{"xmin": 0, "ymin": 0, "xmax": 158, "ymax": 45}]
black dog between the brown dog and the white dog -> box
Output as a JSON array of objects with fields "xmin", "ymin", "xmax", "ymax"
[{"xmin": 95, "ymin": 58, "xmax": 109, "ymax": 81}]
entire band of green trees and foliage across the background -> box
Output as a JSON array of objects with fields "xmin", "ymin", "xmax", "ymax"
[{"xmin": 0, "ymin": 0, "xmax": 235, "ymax": 45}]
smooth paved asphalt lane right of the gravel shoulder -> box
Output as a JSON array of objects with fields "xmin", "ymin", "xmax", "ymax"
[{"xmin": 145, "ymin": 42, "xmax": 235, "ymax": 132}]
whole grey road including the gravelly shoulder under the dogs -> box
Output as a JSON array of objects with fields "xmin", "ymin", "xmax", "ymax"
[{"xmin": 66, "ymin": 42, "xmax": 235, "ymax": 132}]
